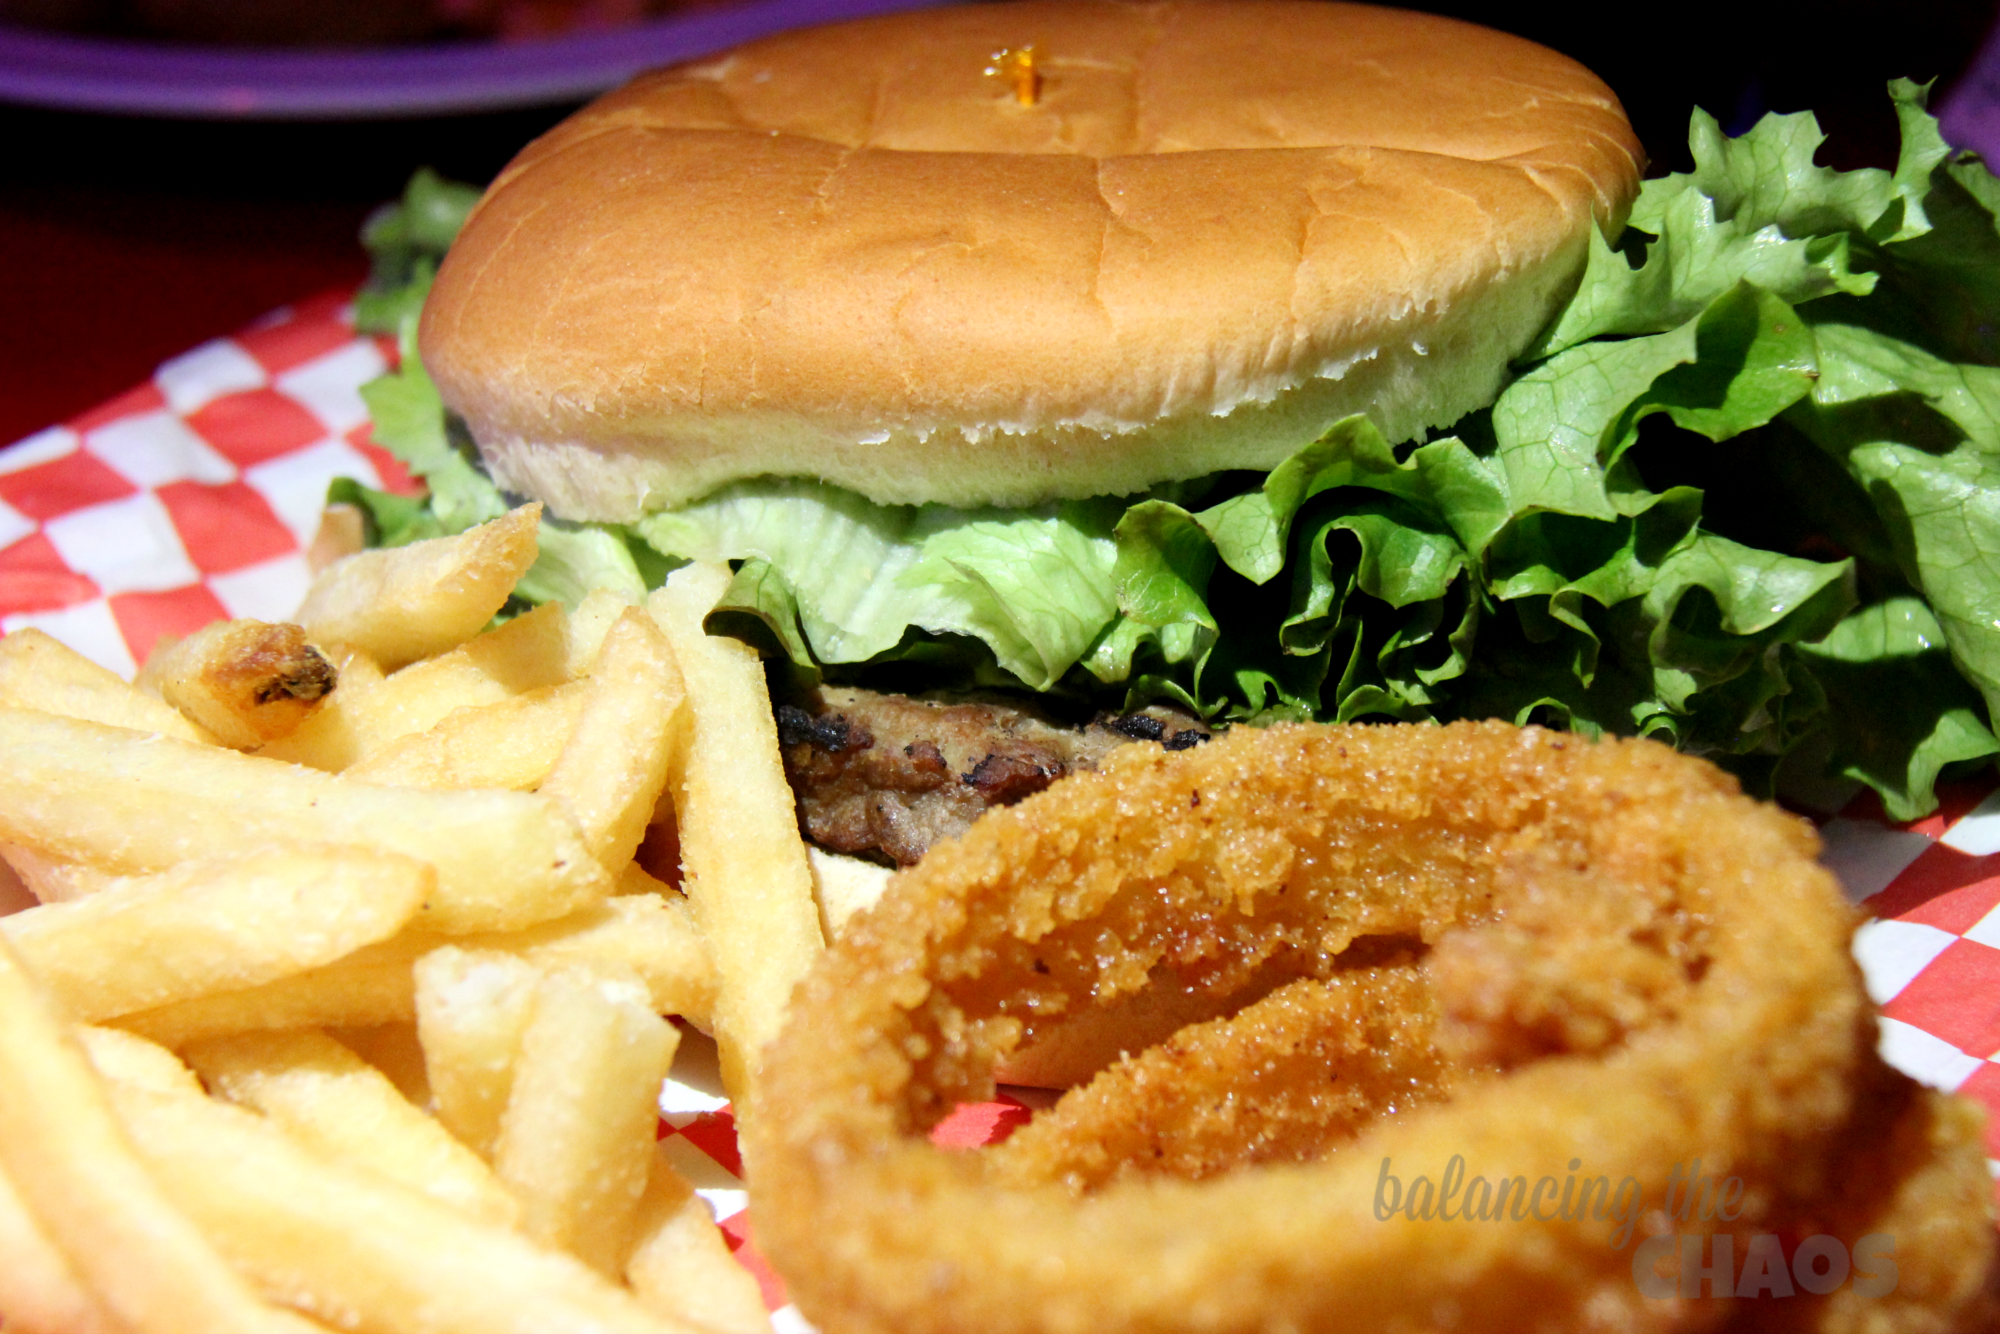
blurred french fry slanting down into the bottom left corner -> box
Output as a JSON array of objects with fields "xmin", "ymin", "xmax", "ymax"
[{"xmin": 0, "ymin": 944, "xmax": 310, "ymax": 1334}]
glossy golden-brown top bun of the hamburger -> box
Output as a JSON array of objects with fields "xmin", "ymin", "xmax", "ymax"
[{"xmin": 422, "ymin": 0, "xmax": 1642, "ymax": 522}]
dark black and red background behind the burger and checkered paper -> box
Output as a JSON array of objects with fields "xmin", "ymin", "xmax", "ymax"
[{"xmin": 0, "ymin": 0, "xmax": 1996, "ymax": 446}]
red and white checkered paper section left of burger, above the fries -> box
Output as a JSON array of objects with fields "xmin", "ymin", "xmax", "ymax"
[{"xmin": 0, "ymin": 294, "xmax": 410, "ymax": 676}]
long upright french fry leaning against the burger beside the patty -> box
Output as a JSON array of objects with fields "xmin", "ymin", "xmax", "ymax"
[{"xmin": 646, "ymin": 564, "xmax": 824, "ymax": 1118}]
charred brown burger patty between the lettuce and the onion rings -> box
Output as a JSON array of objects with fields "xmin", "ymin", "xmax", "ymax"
[{"xmin": 778, "ymin": 686, "xmax": 1208, "ymax": 866}]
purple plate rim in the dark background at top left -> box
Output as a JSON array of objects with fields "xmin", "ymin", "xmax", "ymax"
[{"xmin": 0, "ymin": 0, "xmax": 942, "ymax": 120}]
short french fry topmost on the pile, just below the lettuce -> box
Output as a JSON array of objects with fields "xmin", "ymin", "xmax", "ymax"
[{"xmin": 298, "ymin": 504, "xmax": 542, "ymax": 670}]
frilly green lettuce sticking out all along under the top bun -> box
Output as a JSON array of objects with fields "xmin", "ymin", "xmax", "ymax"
[{"xmin": 352, "ymin": 80, "xmax": 2000, "ymax": 816}]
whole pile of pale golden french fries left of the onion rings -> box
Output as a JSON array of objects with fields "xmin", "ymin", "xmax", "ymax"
[{"xmin": 0, "ymin": 506, "xmax": 820, "ymax": 1334}]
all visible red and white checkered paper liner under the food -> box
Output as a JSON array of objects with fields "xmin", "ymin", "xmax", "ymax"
[{"xmin": 0, "ymin": 292, "xmax": 2000, "ymax": 1330}]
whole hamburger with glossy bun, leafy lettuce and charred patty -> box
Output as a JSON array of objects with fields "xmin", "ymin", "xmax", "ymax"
[{"xmin": 352, "ymin": 0, "xmax": 2000, "ymax": 862}]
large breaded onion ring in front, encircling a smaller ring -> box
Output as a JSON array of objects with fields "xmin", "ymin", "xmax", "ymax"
[{"xmin": 746, "ymin": 724, "xmax": 1994, "ymax": 1334}]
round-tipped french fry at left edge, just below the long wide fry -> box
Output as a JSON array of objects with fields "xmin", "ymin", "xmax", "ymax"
[{"xmin": 0, "ymin": 848, "xmax": 436, "ymax": 1022}]
